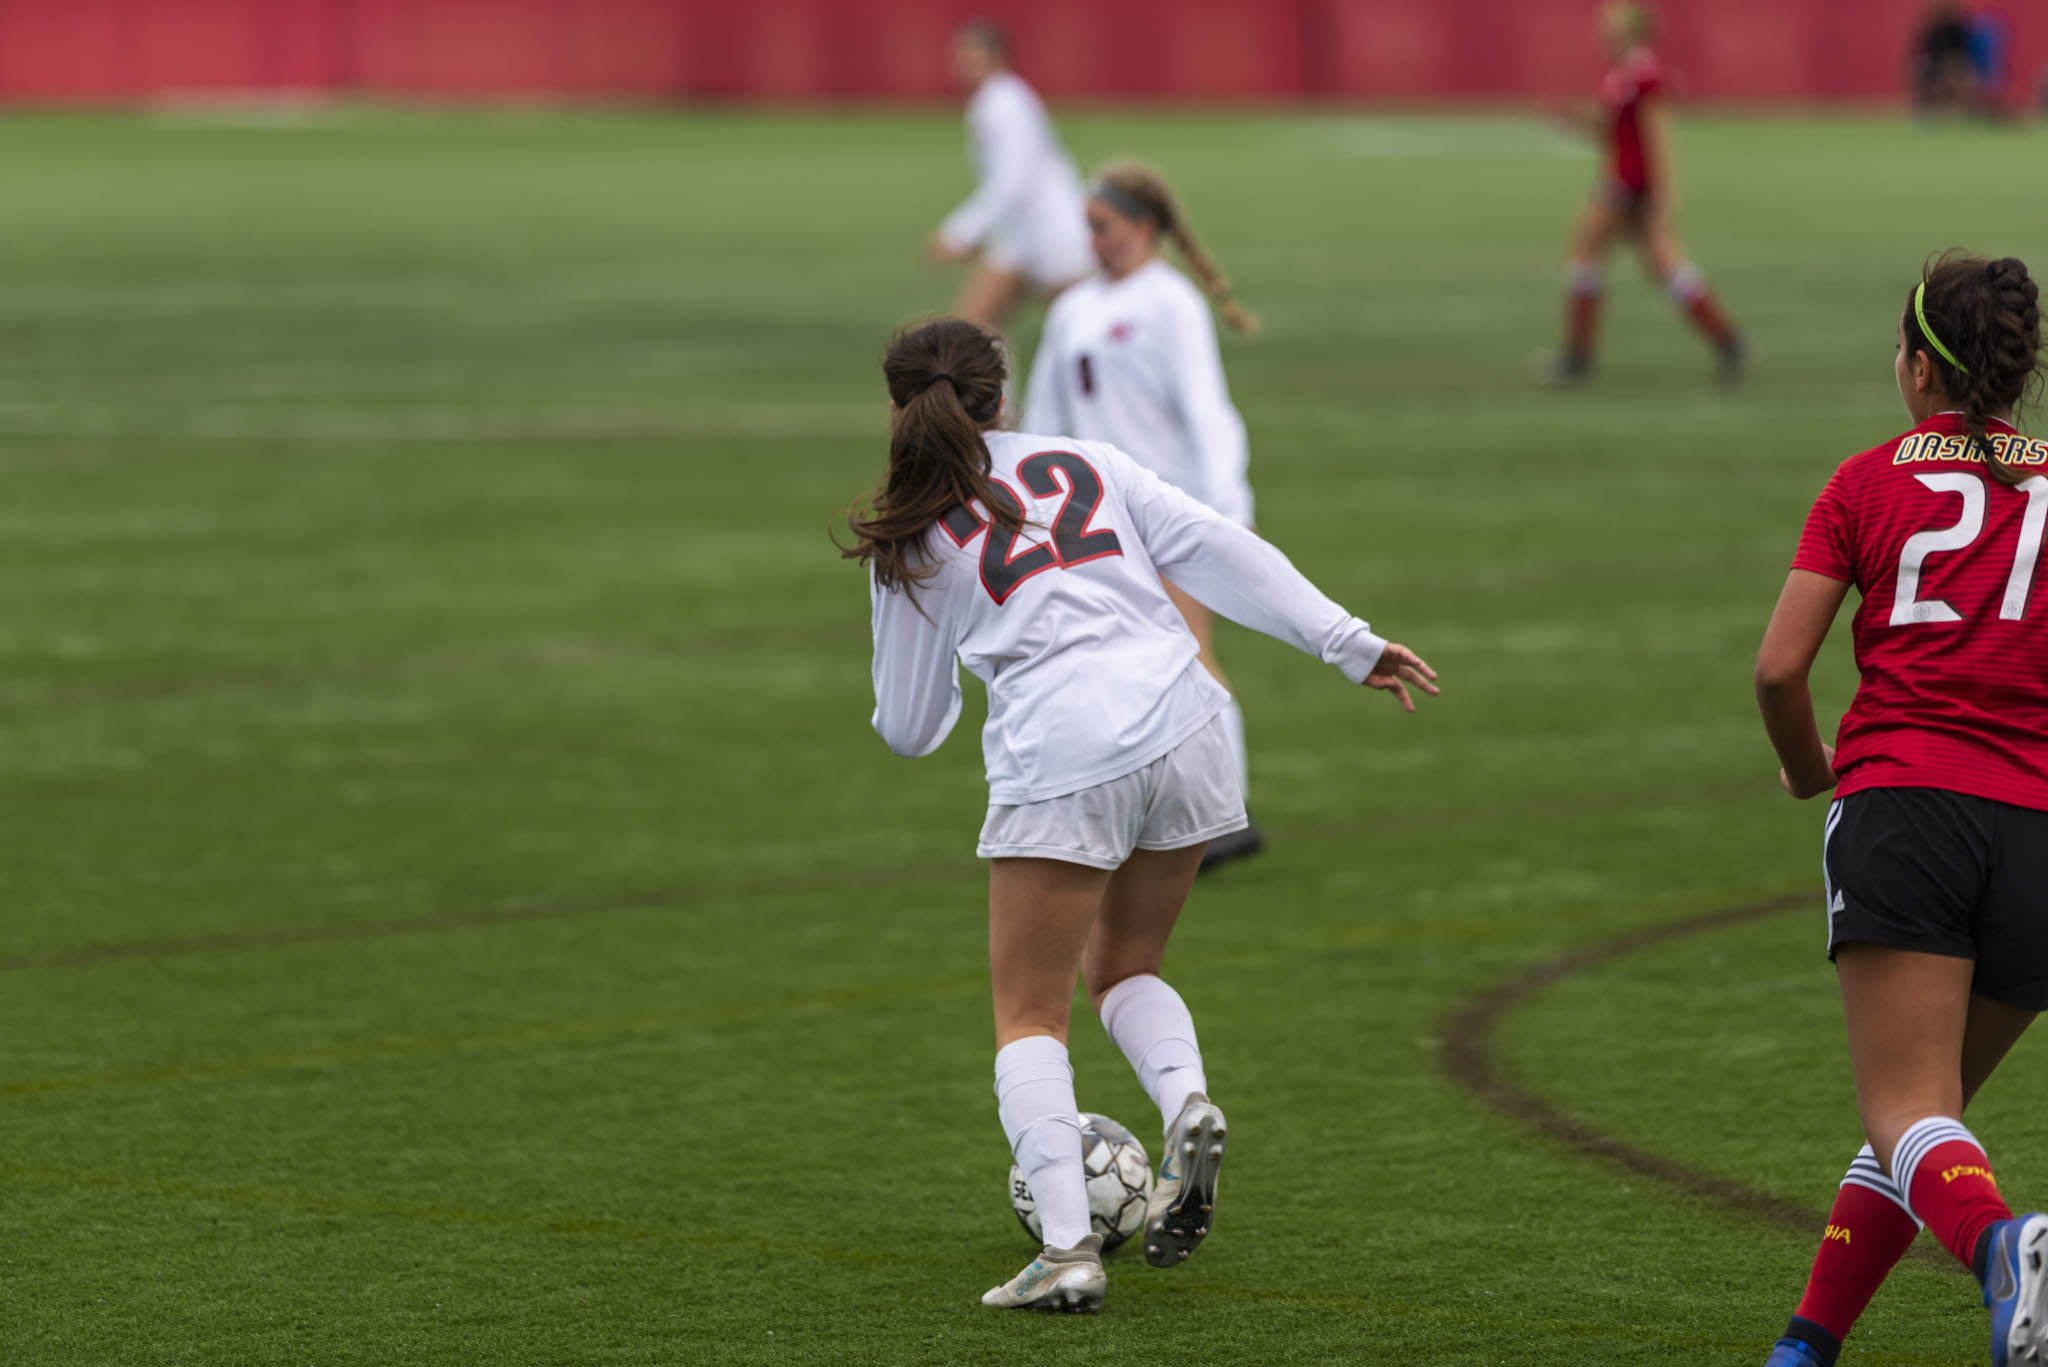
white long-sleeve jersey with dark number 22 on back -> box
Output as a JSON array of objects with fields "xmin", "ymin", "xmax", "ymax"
[{"xmin": 868, "ymin": 432, "xmax": 1386, "ymax": 805}]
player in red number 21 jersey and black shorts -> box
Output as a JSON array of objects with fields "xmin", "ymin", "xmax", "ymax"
[{"xmin": 1757, "ymin": 252, "xmax": 2048, "ymax": 1367}]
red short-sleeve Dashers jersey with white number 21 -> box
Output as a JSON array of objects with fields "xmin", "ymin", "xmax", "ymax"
[{"xmin": 1792, "ymin": 412, "xmax": 2048, "ymax": 810}]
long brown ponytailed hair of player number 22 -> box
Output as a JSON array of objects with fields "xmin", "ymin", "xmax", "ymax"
[{"xmin": 840, "ymin": 318, "xmax": 1024, "ymax": 590}]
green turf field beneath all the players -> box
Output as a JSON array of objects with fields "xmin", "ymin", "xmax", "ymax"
[{"xmin": 0, "ymin": 115, "xmax": 2048, "ymax": 1367}]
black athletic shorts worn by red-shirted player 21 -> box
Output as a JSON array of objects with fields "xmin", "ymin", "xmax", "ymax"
[{"xmin": 1821, "ymin": 787, "xmax": 2048, "ymax": 1010}]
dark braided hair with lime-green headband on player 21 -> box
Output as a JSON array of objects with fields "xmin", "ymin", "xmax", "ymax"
[{"xmin": 1903, "ymin": 250, "xmax": 2042, "ymax": 484}]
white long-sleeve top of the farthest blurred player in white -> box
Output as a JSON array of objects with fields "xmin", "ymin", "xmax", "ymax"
[{"xmin": 938, "ymin": 72, "xmax": 1094, "ymax": 287}]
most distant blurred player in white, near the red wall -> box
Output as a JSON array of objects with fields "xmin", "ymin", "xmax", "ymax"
[{"xmin": 926, "ymin": 25, "xmax": 1094, "ymax": 330}]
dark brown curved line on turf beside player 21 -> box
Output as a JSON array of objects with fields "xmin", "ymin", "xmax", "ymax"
[{"xmin": 1438, "ymin": 892, "xmax": 1960, "ymax": 1271}]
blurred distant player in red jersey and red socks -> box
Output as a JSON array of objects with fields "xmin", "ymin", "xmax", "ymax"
[{"xmin": 1536, "ymin": 4, "xmax": 1745, "ymax": 383}]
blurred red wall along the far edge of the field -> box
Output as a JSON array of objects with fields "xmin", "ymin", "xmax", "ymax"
[{"xmin": 0, "ymin": 0, "xmax": 2048, "ymax": 102}]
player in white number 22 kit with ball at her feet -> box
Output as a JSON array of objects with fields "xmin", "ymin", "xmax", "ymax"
[{"xmin": 846, "ymin": 318, "xmax": 1436, "ymax": 1312}]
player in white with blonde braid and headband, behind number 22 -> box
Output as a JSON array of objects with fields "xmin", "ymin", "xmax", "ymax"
[{"xmin": 1024, "ymin": 162, "xmax": 1264, "ymax": 867}]
